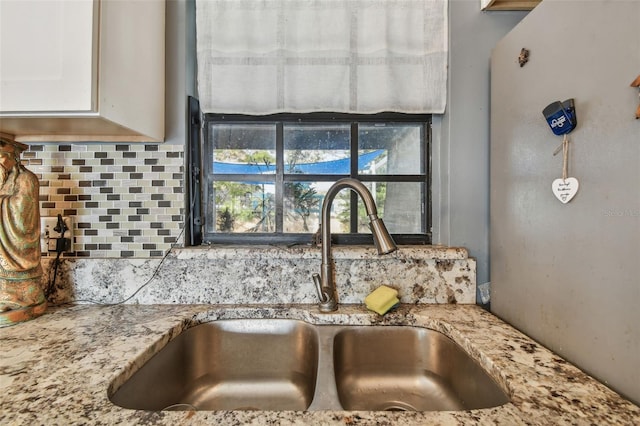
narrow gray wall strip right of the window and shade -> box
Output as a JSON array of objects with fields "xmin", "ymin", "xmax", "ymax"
[{"xmin": 432, "ymin": 0, "xmax": 528, "ymax": 302}]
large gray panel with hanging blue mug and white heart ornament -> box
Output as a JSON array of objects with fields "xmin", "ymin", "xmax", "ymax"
[{"xmin": 490, "ymin": 0, "xmax": 640, "ymax": 403}]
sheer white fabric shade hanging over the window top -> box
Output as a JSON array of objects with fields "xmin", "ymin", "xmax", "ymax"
[{"xmin": 196, "ymin": 0, "xmax": 448, "ymax": 115}]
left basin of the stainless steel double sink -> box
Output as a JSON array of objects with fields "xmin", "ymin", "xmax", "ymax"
[{"xmin": 110, "ymin": 319, "xmax": 318, "ymax": 411}]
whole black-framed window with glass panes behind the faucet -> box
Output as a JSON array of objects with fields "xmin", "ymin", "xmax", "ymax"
[{"xmin": 202, "ymin": 113, "xmax": 431, "ymax": 244}]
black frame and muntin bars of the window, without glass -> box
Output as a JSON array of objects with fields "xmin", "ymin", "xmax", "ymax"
[{"xmin": 196, "ymin": 112, "xmax": 432, "ymax": 246}]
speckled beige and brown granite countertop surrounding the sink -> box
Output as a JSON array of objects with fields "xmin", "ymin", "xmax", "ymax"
[{"xmin": 0, "ymin": 304, "xmax": 640, "ymax": 425}]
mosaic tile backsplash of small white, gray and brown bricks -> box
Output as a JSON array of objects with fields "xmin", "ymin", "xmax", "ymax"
[{"xmin": 22, "ymin": 144, "xmax": 184, "ymax": 258}]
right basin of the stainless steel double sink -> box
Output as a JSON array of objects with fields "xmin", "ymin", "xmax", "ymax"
[{"xmin": 334, "ymin": 326, "xmax": 509, "ymax": 411}]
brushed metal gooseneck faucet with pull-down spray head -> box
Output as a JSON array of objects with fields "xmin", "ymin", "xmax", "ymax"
[{"xmin": 313, "ymin": 178, "xmax": 398, "ymax": 312}]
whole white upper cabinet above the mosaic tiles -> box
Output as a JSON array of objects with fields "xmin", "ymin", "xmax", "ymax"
[{"xmin": 0, "ymin": 0, "xmax": 165, "ymax": 142}]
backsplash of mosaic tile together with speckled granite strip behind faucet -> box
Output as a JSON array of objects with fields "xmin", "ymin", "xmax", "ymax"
[{"xmin": 22, "ymin": 144, "xmax": 476, "ymax": 304}]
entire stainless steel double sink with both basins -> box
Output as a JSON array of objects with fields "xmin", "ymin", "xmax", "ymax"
[{"xmin": 109, "ymin": 319, "xmax": 509, "ymax": 411}]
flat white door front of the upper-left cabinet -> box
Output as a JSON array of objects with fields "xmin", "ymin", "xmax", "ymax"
[{"xmin": 0, "ymin": 0, "xmax": 99, "ymax": 112}]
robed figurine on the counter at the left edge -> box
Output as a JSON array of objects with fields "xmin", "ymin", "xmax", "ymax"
[{"xmin": 0, "ymin": 135, "xmax": 47, "ymax": 327}]
